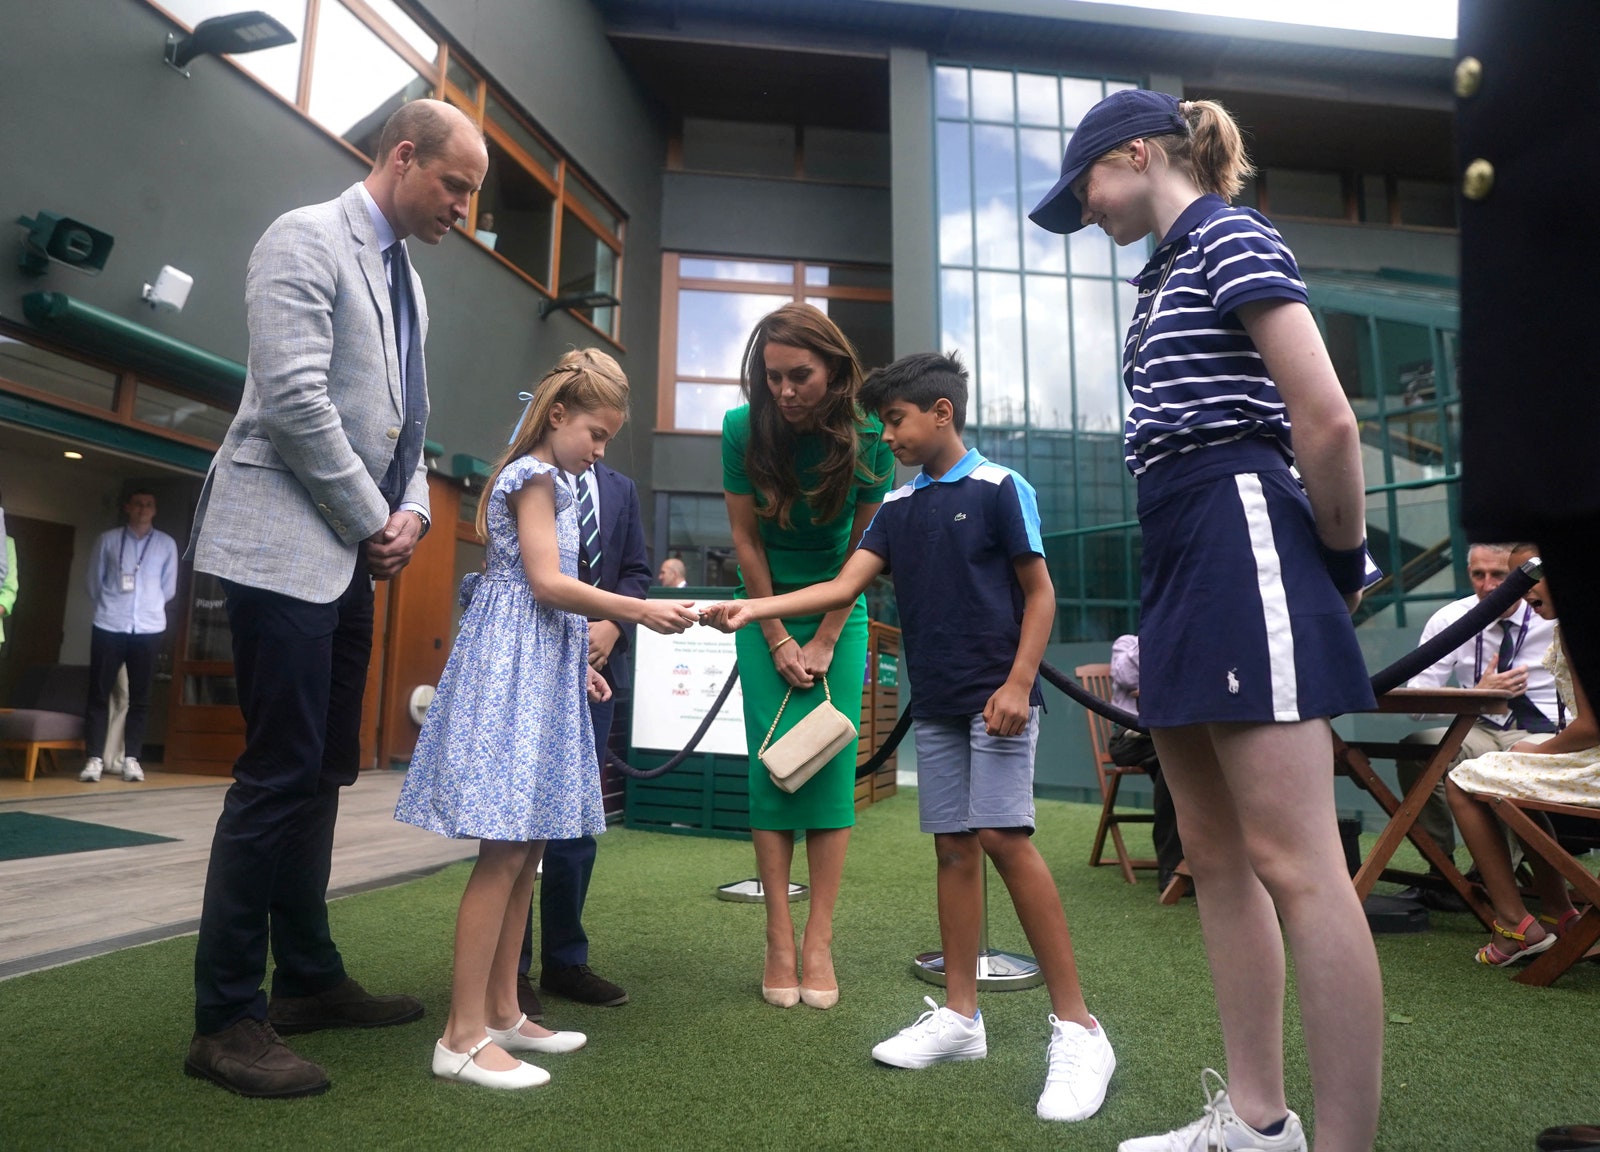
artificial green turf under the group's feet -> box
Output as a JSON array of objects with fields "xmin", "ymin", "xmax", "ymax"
[{"xmin": 0, "ymin": 790, "xmax": 1600, "ymax": 1152}]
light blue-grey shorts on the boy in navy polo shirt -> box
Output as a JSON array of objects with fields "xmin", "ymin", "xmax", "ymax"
[{"xmin": 917, "ymin": 704, "xmax": 1038, "ymax": 832}]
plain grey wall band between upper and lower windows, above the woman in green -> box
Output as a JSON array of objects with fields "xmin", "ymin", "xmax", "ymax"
[{"xmin": 661, "ymin": 173, "xmax": 894, "ymax": 264}]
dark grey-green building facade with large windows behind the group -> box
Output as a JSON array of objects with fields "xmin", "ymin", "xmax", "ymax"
[{"xmin": 0, "ymin": 0, "xmax": 1464, "ymax": 795}]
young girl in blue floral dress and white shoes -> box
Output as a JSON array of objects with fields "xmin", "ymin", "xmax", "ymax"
[{"xmin": 395, "ymin": 349, "xmax": 696, "ymax": 1088}]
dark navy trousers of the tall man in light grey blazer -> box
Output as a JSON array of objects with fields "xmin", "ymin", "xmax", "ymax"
[{"xmin": 195, "ymin": 562, "xmax": 373, "ymax": 1034}]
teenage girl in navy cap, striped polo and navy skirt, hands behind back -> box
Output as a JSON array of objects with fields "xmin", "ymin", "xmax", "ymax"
[{"xmin": 1030, "ymin": 91, "xmax": 1382, "ymax": 1152}]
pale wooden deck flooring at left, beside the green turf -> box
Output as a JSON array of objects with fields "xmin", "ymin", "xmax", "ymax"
[{"xmin": 0, "ymin": 771, "xmax": 477, "ymax": 979}]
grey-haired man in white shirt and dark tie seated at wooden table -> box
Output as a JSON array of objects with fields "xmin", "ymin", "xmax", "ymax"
[{"xmin": 1395, "ymin": 544, "xmax": 1557, "ymax": 904}]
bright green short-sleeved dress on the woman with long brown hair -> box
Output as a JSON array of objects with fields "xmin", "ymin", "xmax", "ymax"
[{"xmin": 722, "ymin": 406, "xmax": 894, "ymax": 830}]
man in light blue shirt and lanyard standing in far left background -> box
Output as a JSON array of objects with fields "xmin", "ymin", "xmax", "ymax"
[{"xmin": 78, "ymin": 488, "xmax": 178, "ymax": 784}]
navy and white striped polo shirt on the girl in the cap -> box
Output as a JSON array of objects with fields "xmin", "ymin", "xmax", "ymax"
[{"xmin": 1122, "ymin": 195, "xmax": 1306, "ymax": 475}]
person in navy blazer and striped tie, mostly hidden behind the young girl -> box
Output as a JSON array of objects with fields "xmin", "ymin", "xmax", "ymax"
[{"xmin": 517, "ymin": 461, "xmax": 653, "ymax": 1021}]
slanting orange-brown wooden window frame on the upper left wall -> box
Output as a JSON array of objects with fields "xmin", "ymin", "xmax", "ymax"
[{"xmin": 144, "ymin": 0, "xmax": 627, "ymax": 352}]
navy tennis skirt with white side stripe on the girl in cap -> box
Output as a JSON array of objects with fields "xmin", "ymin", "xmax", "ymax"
[{"xmin": 1139, "ymin": 440, "xmax": 1374, "ymax": 728}]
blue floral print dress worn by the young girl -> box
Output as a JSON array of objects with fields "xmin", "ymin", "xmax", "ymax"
[{"xmin": 395, "ymin": 456, "xmax": 605, "ymax": 840}]
